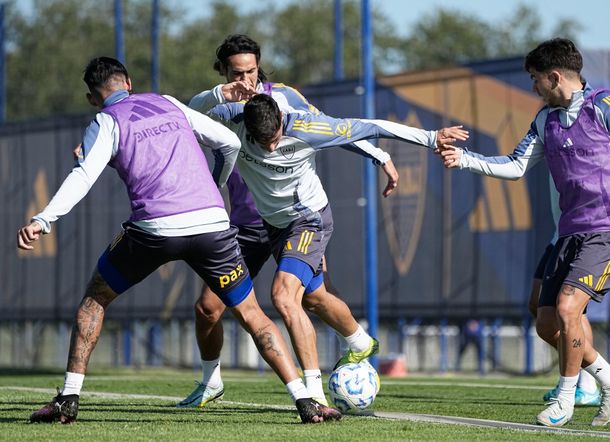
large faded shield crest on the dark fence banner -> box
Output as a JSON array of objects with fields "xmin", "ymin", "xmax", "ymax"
[{"xmin": 378, "ymin": 114, "xmax": 428, "ymax": 275}]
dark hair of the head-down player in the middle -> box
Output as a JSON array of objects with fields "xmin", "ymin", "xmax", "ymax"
[{"xmin": 244, "ymin": 94, "xmax": 282, "ymax": 144}]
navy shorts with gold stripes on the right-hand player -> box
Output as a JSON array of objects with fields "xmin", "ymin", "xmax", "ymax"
[{"xmin": 538, "ymin": 232, "xmax": 610, "ymax": 307}]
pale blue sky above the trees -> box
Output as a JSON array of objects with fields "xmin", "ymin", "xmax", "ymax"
[{"xmin": 160, "ymin": 0, "xmax": 610, "ymax": 49}]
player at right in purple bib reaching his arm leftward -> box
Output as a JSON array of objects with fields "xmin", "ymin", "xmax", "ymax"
[{"xmin": 441, "ymin": 38, "xmax": 610, "ymax": 426}]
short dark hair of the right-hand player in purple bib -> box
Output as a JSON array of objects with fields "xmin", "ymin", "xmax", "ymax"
[{"xmin": 525, "ymin": 38, "xmax": 582, "ymax": 74}]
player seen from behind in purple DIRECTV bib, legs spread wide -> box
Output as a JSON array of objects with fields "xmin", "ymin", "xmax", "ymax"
[{"xmin": 17, "ymin": 57, "xmax": 341, "ymax": 423}]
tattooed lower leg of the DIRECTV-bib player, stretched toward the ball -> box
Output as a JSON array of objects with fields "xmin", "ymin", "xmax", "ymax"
[{"xmin": 231, "ymin": 290, "xmax": 299, "ymax": 384}]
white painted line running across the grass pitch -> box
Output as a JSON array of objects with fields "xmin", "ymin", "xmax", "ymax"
[{"xmin": 0, "ymin": 386, "xmax": 610, "ymax": 438}]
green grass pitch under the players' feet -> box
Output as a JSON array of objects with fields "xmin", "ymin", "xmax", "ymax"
[{"xmin": 0, "ymin": 369, "xmax": 610, "ymax": 442}]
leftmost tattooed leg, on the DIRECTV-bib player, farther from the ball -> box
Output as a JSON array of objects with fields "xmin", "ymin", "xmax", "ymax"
[{"xmin": 66, "ymin": 269, "xmax": 117, "ymax": 374}]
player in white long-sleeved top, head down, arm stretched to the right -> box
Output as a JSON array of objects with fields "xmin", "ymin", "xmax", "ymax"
[{"xmin": 202, "ymin": 94, "xmax": 467, "ymax": 412}]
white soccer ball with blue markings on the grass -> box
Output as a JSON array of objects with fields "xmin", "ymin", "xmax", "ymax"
[{"xmin": 328, "ymin": 361, "xmax": 380, "ymax": 414}]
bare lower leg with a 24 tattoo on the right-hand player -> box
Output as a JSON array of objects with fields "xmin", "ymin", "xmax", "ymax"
[{"xmin": 557, "ymin": 284, "xmax": 590, "ymax": 376}]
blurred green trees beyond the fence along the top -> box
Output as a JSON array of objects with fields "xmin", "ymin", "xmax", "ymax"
[{"xmin": 0, "ymin": 0, "xmax": 580, "ymax": 120}]
